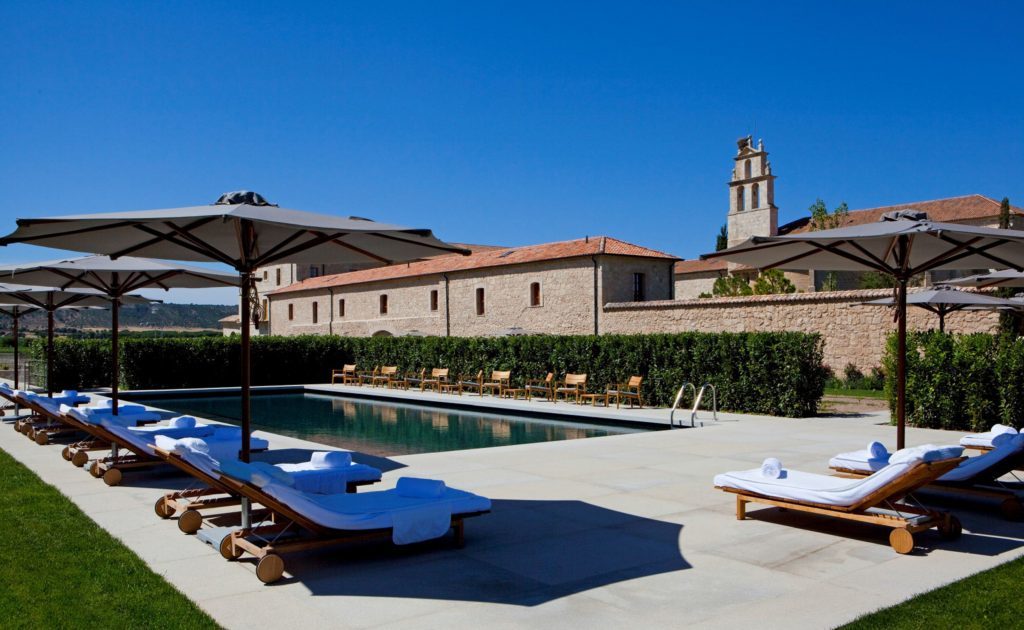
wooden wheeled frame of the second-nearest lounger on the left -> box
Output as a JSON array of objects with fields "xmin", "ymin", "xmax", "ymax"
[{"xmin": 150, "ymin": 445, "xmax": 377, "ymax": 534}]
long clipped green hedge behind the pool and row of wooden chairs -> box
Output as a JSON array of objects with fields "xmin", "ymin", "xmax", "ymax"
[{"xmin": 36, "ymin": 333, "xmax": 826, "ymax": 417}]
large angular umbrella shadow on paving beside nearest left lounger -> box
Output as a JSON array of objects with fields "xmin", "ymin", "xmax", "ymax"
[{"xmin": 260, "ymin": 500, "xmax": 690, "ymax": 606}]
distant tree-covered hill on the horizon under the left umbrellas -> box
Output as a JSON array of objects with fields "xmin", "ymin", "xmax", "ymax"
[{"xmin": 0, "ymin": 304, "xmax": 238, "ymax": 330}]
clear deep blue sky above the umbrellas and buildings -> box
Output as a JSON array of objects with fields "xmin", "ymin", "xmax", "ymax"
[{"xmin": 0, "ymin": 0, "xmax": 1024, "ymax": 303}]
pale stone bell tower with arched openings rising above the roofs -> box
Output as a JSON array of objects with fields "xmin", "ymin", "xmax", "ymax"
[{"xmin": 728, "ymin": 135, "xmax": 778, "ymax": 247}]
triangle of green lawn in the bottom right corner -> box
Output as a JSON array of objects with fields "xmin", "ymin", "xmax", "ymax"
[{"xmin": 843, "ymin": 559, "xmax": 1024, "ymax": 630}]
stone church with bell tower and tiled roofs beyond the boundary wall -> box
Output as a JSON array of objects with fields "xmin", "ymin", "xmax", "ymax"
[{"xmin": 675, "ymin": 136, "xmax": 1024, "ymax": 299}]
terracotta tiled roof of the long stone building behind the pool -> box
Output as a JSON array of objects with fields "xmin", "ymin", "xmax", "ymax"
[{"xmin": 269, "ymin": 237, "xmax": 678, "ymax": 295}]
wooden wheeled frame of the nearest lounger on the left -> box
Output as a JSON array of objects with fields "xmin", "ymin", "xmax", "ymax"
[{"xmin": 214, "ymin": 476, "xmax": 489, "ymax": 584}]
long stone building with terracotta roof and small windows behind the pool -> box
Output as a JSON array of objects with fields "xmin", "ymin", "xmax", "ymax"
[{"xmin": 264, "ymin": 237, "xmax": 677, "ymax": 336}]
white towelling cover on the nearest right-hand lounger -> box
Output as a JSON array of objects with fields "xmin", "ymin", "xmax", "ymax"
[{"xmin": 715, "ymin": 447, "xmax": 962, "ymax": 507}]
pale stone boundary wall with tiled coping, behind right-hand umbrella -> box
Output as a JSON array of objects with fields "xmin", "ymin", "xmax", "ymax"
[{"xmin": 601, "ymin": 289, "xmax": 998, "ymax": 372}]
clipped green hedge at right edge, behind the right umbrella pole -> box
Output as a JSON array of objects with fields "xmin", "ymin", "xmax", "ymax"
[{"xmin": 884, "ymin": 331, "xmax": 1024, "ymax": 431}]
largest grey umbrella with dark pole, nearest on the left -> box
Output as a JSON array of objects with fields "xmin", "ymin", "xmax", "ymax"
[{"xmin": 0, "ymin": 192, "xmax": 470, "ymax": 463}]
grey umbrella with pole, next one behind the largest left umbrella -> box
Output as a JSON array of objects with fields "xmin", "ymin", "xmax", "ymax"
[{"xmin": 0, "ymin": 256, "xmax": 239, "ymax": 415}]
